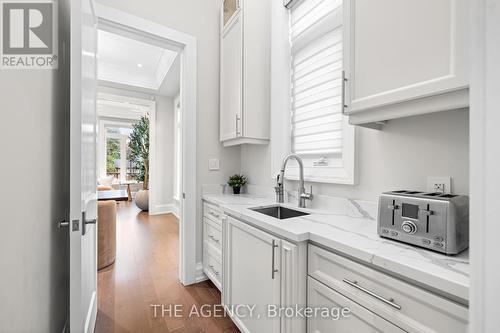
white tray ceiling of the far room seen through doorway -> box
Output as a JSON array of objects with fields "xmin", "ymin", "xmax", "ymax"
[{"xmin": 97, "ymin": 30, "xmax": 180, "ymax": 96}]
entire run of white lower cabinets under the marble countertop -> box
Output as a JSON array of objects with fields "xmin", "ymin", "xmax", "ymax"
[{"xmin": 218, "ymin": 210, "xmax": 469, "ymax": 333}]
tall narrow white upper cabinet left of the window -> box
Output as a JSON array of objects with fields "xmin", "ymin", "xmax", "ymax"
[{"xmin": 220, "ymin": 0, "xmax": 271, "ymax": 146}]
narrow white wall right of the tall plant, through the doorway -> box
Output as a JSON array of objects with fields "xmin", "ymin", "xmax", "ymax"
[{"xmin": 154, "ymin": 96, "xmax": 175, "ymax": 212}]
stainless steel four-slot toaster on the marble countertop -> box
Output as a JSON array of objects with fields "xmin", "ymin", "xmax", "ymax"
[{"xmin": 378, "ymin": 190, "xmax": 469, "ymax": 254}]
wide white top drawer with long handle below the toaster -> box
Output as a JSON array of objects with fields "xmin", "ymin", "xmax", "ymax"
[{"xmin": 308, "ymin": 245, "xmax": 468, "ymax": 333}]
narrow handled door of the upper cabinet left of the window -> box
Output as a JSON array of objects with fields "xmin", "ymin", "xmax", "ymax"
[{"xmin": 220, "ymin": 13, "xmax": 243, "ymax": 141}]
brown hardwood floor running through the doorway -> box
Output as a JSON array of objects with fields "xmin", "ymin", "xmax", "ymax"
[{"xmin": 95, "ymin": 202, "xmax": 239, "ymax": 333}]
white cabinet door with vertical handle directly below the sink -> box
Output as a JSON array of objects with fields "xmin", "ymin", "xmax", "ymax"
[{"xmin": 223, "ymin": 217, "xmax": 281, "ymax": 333}]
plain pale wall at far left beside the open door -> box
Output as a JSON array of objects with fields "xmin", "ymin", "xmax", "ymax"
[{"xmin": 0, "ymin": 1, "xmax": 69, "ymax": 332}]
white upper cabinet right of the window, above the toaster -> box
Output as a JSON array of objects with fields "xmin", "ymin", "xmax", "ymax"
[{"xmin": 344, "ymin": 0, "xmax": 469, "ymax": 124}]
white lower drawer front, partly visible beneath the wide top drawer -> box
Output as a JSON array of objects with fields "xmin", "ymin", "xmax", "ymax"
[{"xmin": 307, "ymin": 277, "xmax": 405, "ymax": 333}]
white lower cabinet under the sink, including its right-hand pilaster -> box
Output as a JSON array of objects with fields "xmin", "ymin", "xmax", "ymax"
[{"xmin": 223, "ymin": 217, "xmax": 307, "ymax": 333}]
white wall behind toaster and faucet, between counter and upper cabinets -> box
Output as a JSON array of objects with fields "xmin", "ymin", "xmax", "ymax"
[{"xmin": 241, "ymin": 110, "xmax": 469, "ymax": 200}]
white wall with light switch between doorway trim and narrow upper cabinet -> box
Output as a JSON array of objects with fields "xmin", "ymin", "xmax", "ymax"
[{"xmin": 98, "ymin": 0, "xmax": 240, "ymax": 262}]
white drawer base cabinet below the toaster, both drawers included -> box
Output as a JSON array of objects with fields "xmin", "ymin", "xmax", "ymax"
[{"xmin": 308, "ymin": 244, "xmax": 469, "ymax": 333}]
